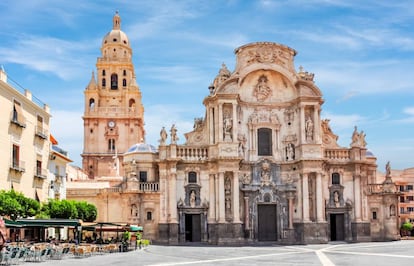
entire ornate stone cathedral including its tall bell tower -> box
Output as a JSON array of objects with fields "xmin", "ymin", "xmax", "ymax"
[{"xmin": 67, "ymin": 14, "xmax": 399, "ymax": 244}]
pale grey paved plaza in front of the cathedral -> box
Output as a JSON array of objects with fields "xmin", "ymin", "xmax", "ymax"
[{"xmin": 23, "ymin": 240, "xmax": 414, "ymax": 266}]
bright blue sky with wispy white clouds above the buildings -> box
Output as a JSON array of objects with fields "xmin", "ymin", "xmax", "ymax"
[{"xmin": 0, "ymin": 0, "xmax": 414, "ymax": 171}]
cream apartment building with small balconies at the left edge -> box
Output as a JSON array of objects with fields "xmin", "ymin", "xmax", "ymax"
[{"xmin": 0, "ymin": 67, "xmax": 51, "ymax": 202}]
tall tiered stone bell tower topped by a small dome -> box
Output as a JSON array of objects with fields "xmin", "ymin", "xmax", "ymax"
[{"xmin": 81, "ymin": 12, "xmax": 145, "ymax": 179}]
